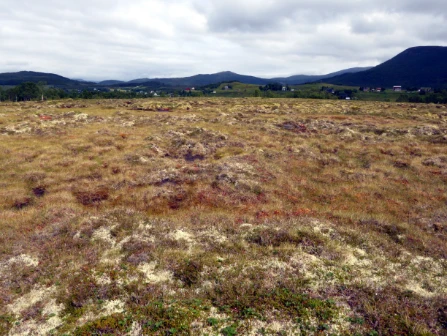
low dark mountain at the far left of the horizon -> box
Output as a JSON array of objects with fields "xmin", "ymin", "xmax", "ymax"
[{"xmin": 0, "ymin": 71, "xmax": 86, "ymax": 85}]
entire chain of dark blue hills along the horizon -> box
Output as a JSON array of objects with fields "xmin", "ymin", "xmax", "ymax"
[{"xmin": 10, "ymin": 46, "xmax": 447, "ymax": 88}]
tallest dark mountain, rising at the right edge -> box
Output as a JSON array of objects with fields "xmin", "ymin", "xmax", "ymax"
[{"xmin": 324, "ymin": 46, "xmax": 447, "ymax": 88}]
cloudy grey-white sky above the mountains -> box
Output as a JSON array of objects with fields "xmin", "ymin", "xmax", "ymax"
[{"xmin": 0, "ymin": 0, "xmax": 447, "ymax": 80}]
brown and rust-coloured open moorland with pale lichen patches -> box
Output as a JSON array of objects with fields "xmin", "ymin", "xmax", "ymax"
[{"xmin": 0, "ymin": 98, "xmax": 447, "ymax": 336}]
